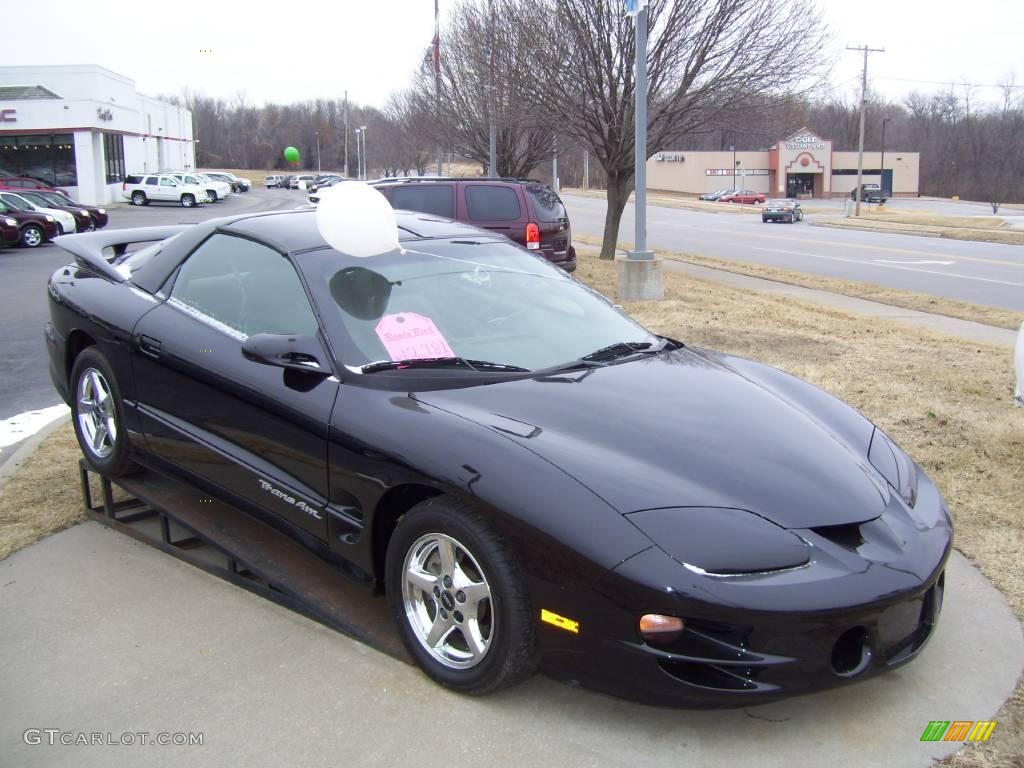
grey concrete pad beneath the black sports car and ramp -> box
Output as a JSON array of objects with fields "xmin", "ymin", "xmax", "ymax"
[{"xmin": 0, "ymin": 522, "xmax": 1024, "ymax": 768}]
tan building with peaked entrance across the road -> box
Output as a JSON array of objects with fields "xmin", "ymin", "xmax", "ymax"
[{"xmin": 647, "ymin": 128, "xmax": 921, "ymax": 198}]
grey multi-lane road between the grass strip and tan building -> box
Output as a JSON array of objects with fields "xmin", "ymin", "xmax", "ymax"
[{"xmin": 562, "ymin": 195, "xmax": 1024, "ymax": 310}]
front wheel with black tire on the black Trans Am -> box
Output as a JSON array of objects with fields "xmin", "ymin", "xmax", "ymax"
[{"xmin": 385, "ymin": 496, "xmax": 539, "ymax": 695}]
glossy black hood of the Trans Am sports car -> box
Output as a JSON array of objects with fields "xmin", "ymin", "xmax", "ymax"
[{"xmin": 416, "ymin": 349, "xmax": 889, "ymax": 528}]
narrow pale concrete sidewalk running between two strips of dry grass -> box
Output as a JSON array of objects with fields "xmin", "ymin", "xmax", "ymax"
[{"xmin": 574, "ymin": 243, "xmax": 1017, "ymax": 347}]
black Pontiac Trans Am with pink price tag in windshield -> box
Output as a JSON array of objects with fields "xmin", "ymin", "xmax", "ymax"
[{"xmin": 39, "ymin": 211, "xmax": 951, "ymax": 706}]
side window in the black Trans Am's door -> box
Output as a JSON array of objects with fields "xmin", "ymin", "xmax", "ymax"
[{"xmin": 171, "ymin": 234, "xmax": 316, "ymax": 336}]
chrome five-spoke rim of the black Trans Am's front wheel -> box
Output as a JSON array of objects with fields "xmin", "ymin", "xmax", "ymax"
[{"xmin": 401, "ymin": 534, "xmax": 496, "ymax": 670}]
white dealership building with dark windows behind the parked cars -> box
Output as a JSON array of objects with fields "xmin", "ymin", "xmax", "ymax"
[{"xmin": 0, "ymin": 66, "xmax": 196, "ymax": 205}]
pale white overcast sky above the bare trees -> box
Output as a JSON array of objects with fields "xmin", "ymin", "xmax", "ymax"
[{"xmin": 0, "ymin": 0, "xmax": 1024, "ymax": 106}]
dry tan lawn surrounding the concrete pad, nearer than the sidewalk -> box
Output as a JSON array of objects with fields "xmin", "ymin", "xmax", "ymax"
[{"xmin": 0, "ymin": 246, "xmax": 1024, "ymax": 768}]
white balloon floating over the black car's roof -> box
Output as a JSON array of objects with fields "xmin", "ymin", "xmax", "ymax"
[{"xmin": 316, "ymin": 181, "xmax": 398, "ymax": 258}]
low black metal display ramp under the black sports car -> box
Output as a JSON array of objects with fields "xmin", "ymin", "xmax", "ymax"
[{"xmin": 79, "ymin": 459, "xmax": 412, "ymax": 663}]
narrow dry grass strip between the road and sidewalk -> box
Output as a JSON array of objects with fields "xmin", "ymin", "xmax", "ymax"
[{"xmin": 572, "ymin": 234, "xmax": 1024, "ymax": 331}]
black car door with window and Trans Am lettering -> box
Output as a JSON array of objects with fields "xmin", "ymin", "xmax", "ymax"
[{"xmin": 132, "ymin": 232, "xmax": 338, "ymax": 539}]
